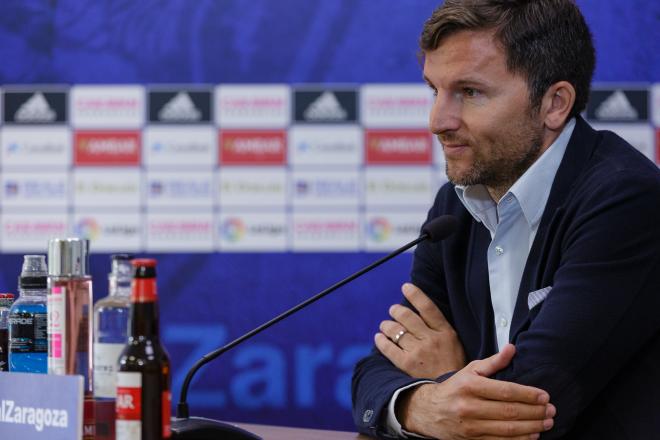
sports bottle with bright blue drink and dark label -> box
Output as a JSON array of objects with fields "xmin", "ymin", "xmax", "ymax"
[{"xmin": 9, "ymin": 255, "xmax": 48, "ymax": 373}]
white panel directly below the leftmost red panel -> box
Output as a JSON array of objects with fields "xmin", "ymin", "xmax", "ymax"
[{"xmin": 73, "ymin": 167, "xmax": 142, "ymax": 209}]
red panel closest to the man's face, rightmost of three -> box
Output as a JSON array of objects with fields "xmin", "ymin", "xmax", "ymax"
[{"xmin": 365, "ymin": 130, "xmax": 432, "ymax": 165}]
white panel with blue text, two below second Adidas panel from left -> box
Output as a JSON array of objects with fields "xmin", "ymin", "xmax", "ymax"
[{"xmin": 145, "ymin": 171, "xmax": 213, "ymax": 209}]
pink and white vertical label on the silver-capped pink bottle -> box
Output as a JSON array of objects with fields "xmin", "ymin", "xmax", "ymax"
[{"xmin": 47, "ymin": 286, "xmax": 66, "ymax": 374}]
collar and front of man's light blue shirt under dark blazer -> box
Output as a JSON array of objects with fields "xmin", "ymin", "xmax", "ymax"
[{"xmin": 454, "ymin": 119, "xmax": 575, "ymax": 350}]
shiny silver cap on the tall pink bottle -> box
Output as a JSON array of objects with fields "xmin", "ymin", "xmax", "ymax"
[{"xmin": 48, "ymin": 238, "xmax": 89, "ymax": 276}]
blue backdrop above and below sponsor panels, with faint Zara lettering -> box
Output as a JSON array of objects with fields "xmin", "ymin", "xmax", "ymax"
[{"xmin": 0, "ymin": 0, "xmax": 660, "ymax": 430}]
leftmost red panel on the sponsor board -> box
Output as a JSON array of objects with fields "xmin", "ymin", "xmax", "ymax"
[{"xmin": 74, "ymin": 131, "xmax": 140, "ymax": 166}]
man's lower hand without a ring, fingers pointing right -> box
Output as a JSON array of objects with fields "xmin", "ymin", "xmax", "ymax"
[{"xmin": 396, "ymin": 344, "xmax": 556, "ymax": 440}]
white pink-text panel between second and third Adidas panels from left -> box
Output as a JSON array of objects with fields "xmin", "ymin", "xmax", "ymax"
[{"xmin": 215, "ymin": 85, "xmax": 291, "ymax": 128}]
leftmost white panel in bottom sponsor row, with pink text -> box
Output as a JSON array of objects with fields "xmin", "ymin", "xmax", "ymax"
[{"xmin": 0, "ymin": 213, "xmax": 69, "ymax": 253}]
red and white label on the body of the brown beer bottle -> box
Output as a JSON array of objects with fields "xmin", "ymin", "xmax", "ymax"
[{"xmin": 115, "ymin": 371, "xmax": 142, "ymax": 440}]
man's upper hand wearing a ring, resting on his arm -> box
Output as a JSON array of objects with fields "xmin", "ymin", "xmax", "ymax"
[{"xmin": 374, "ymin": 283, "xmax": 465, "ymax": 379}]
